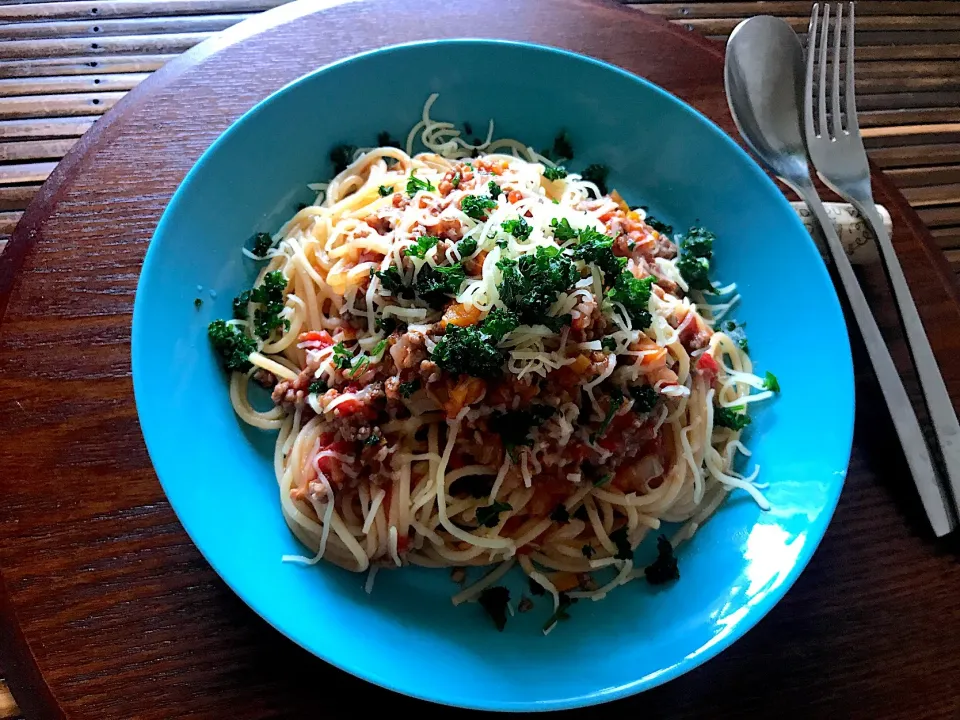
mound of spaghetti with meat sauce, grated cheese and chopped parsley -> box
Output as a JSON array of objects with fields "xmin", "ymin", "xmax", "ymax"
[{"xmin": 210, "ymin": 96, "xmax": 779, "ymax": 630}]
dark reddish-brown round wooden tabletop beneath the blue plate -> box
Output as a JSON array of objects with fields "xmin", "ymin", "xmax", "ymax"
[{"xmin": 0, "ymin": 0, "xmax": 960, "ymax": 720}]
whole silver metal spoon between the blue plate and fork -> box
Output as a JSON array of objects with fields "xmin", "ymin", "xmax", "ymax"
[{"xmin": 724, "ymin": 16, "xmax": 954, "ymax": 536}]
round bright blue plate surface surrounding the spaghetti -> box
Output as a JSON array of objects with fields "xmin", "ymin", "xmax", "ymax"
[{"xmin": 133, "ymin": 40, "xmax": 853, "ymax": 711}]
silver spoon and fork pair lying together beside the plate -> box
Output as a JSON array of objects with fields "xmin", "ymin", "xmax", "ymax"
[{"xmin": 724, "ymin": 2, "xmax": 960, "ymax": 536}]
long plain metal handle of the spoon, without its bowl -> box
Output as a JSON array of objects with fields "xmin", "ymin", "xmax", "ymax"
[{"xmin": 794, "ymin": 184, "xmax": 954, "ymax": 537}]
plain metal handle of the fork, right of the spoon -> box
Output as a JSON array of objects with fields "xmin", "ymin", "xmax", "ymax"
[{"xmin": 851, "ymin": 199, "xmax": 960, "ymax": 516}]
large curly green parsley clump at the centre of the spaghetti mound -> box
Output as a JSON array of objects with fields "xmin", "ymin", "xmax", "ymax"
[{"xmin": 497, "ymin": 246, "xmax": 580, "ymax": 329}]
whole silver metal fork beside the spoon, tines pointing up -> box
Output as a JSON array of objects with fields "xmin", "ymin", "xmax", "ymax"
[{"xmin": 805, "ymin": 2, "xmax": 960, "ymax": 516}]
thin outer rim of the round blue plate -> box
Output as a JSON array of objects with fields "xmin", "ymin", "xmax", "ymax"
[{"xmin": 131, "ymin": 36, "xmax": 856, "ymax": 712}]
